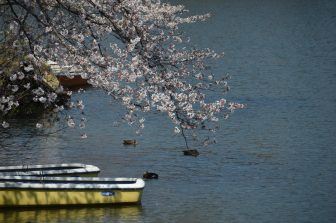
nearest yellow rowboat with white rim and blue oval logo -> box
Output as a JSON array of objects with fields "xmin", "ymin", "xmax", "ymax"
[{"xmin": 0, "ymin": 176, "xmax": 145, "ymax": 207}]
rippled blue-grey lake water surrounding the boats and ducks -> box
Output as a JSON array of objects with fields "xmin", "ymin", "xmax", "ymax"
[{"xmin": 0, "ymin": 0, "xmax": 336, "ymax": 223}]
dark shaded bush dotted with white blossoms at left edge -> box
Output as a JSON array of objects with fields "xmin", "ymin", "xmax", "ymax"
[{"xmin": 0, "ymin": 55, "xmax": 68, "ymax": 128}]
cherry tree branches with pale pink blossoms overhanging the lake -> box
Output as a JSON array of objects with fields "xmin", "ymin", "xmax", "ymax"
[{"xmin": 0, "ymin": 0, "xmax": 244, "ymax": 147}]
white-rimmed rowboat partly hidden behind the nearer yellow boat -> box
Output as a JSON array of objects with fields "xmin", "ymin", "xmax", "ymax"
[{"xmin": 0, "ymin": 163, "xmax": 100, "ymax": 177}]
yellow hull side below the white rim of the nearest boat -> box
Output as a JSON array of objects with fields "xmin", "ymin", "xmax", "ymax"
[{"xmin": 0, "ymin": 189, "xmax": 142, "ymax": 207}]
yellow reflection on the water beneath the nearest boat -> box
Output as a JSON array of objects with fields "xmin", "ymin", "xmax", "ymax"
[{"xmin": 0, "ymin": 205, "xmax": 142, "ymax": 223}]
